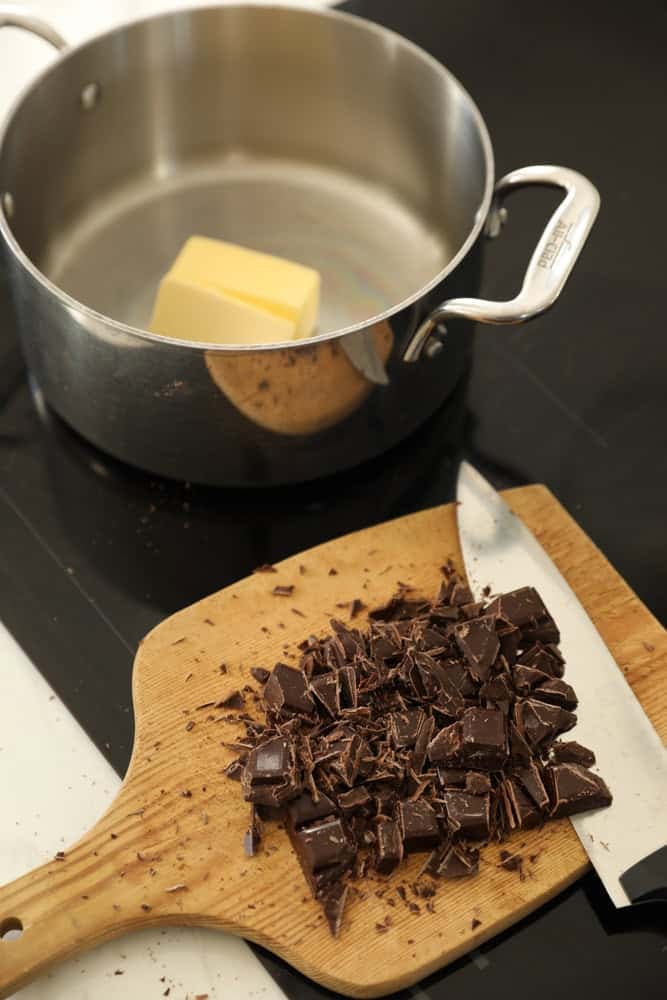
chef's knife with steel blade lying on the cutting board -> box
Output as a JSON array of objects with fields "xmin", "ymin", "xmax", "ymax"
[{"xmin": 457, "ymin": 462, "xmax": 667, "ymax": 906}]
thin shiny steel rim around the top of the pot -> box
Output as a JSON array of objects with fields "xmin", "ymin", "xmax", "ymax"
[{"xmin": 0, "ymin": 2, "xmax": 495, "ymax": 354}]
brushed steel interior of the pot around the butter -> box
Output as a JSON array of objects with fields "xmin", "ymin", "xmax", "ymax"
[{"xmin": 0, "ymin": 6, "xmax": 492, "ymax": 333}]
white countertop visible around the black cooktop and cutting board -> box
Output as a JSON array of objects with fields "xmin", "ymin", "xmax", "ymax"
[{"xmin": 0, "ymin": 0, "xmax": 332, "ymax": 1000}]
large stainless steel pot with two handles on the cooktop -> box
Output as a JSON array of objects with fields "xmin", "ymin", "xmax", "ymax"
[{"xmin": 0, "ymin": 0, "xmax": 599, "ymax": 485}]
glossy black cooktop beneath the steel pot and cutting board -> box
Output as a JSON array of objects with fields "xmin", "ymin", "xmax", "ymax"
[{"xmin": 0, "ymin": 0, "xmax": 667, "ymax": 1000}]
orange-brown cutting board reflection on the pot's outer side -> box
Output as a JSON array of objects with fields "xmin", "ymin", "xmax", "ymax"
[{"xmin": 206, "ymin": 322, "xmax": 394, "ymax": 436}]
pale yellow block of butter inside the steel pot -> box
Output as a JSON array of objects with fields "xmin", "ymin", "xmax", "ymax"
[{"xmin": 149, "ymin": 236, "xmax": 320, "ymax": 344}]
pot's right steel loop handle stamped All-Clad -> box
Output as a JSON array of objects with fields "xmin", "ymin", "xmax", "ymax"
[{"xmin": 403, "ymin": 166, "xmax": 600, "ymax": 361}]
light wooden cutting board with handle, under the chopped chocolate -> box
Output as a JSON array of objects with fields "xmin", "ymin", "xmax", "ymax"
[{"xmin": 0, "ymin": 486, "xmax": 667, "ymax": 997}]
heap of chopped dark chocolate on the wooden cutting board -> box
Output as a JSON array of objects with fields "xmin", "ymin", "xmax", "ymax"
[{"xmin": 224, "ymin": 576, "xmax": 611, "ymax": 935}]
